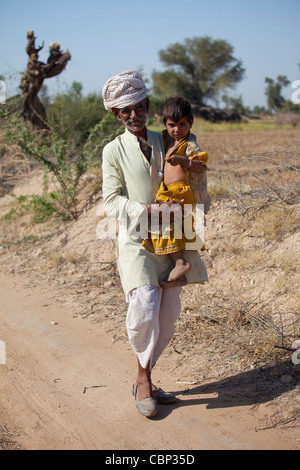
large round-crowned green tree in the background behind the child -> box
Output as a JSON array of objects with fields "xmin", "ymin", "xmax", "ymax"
[{"xmin": 152, "ymin": 36, "xmax": 245, "ymax": 105}]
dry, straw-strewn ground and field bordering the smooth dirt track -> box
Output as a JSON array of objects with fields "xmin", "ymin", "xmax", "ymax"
[{"xmin": 0, "ymin": 123, "xmax": 300, "ymax": 448}]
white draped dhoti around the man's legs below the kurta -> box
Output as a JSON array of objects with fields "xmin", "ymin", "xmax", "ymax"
[{"xmin": 126, "ymin": 286, "xmax": 182, "ymax": 369}]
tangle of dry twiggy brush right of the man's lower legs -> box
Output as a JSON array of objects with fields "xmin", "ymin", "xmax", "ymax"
[{"xmin": 174, "ymin": 286, "xmax": 292, "ymax": 370}]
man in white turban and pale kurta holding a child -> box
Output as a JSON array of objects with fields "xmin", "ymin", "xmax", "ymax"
[{"xmin": 102, "ymin": 71, "xmax": 207, "ymax": 418}]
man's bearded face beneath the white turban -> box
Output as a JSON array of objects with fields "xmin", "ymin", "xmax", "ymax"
[{"xmin": 112, "ymin": 98, "xmax": 149, "ymax": 136}]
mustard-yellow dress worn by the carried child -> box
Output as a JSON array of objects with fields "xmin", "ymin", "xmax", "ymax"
[{"xmin": 142, "ymin": 131, "xmax": 210, "ymax": 255}]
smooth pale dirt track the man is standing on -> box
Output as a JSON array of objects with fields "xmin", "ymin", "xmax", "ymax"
[{"xmin": 0, "ymin": 274, "xmax": 299, "ymax": 450}]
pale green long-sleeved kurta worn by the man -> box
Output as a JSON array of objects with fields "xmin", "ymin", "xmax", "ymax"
[{"xmin": 103, "ymin": 129, "xmax": 208, "ymax": 294}]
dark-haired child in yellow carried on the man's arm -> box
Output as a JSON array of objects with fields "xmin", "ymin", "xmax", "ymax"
[{"xmin": 142, "ymin": 95, "xmax": 210, "ymax": 288}]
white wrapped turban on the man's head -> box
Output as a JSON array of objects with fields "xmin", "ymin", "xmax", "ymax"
[{"xmin": 102, "ymin": 70, "xmax": 146, "ymax": 109}]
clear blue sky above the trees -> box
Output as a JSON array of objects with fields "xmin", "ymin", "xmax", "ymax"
[{"xmin": 0, "ymin": 0, "xmax": 300, "ymax": 107}]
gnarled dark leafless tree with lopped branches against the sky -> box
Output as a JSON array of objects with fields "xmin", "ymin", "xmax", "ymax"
[{"xmin": 20, "ymin": 30, "xmax": 71, "ymax": 130}]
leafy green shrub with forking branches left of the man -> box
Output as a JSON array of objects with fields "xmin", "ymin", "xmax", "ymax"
[{"xmin": 0, "ymin": 112, "xmax": 121, "ymax": 222}]
